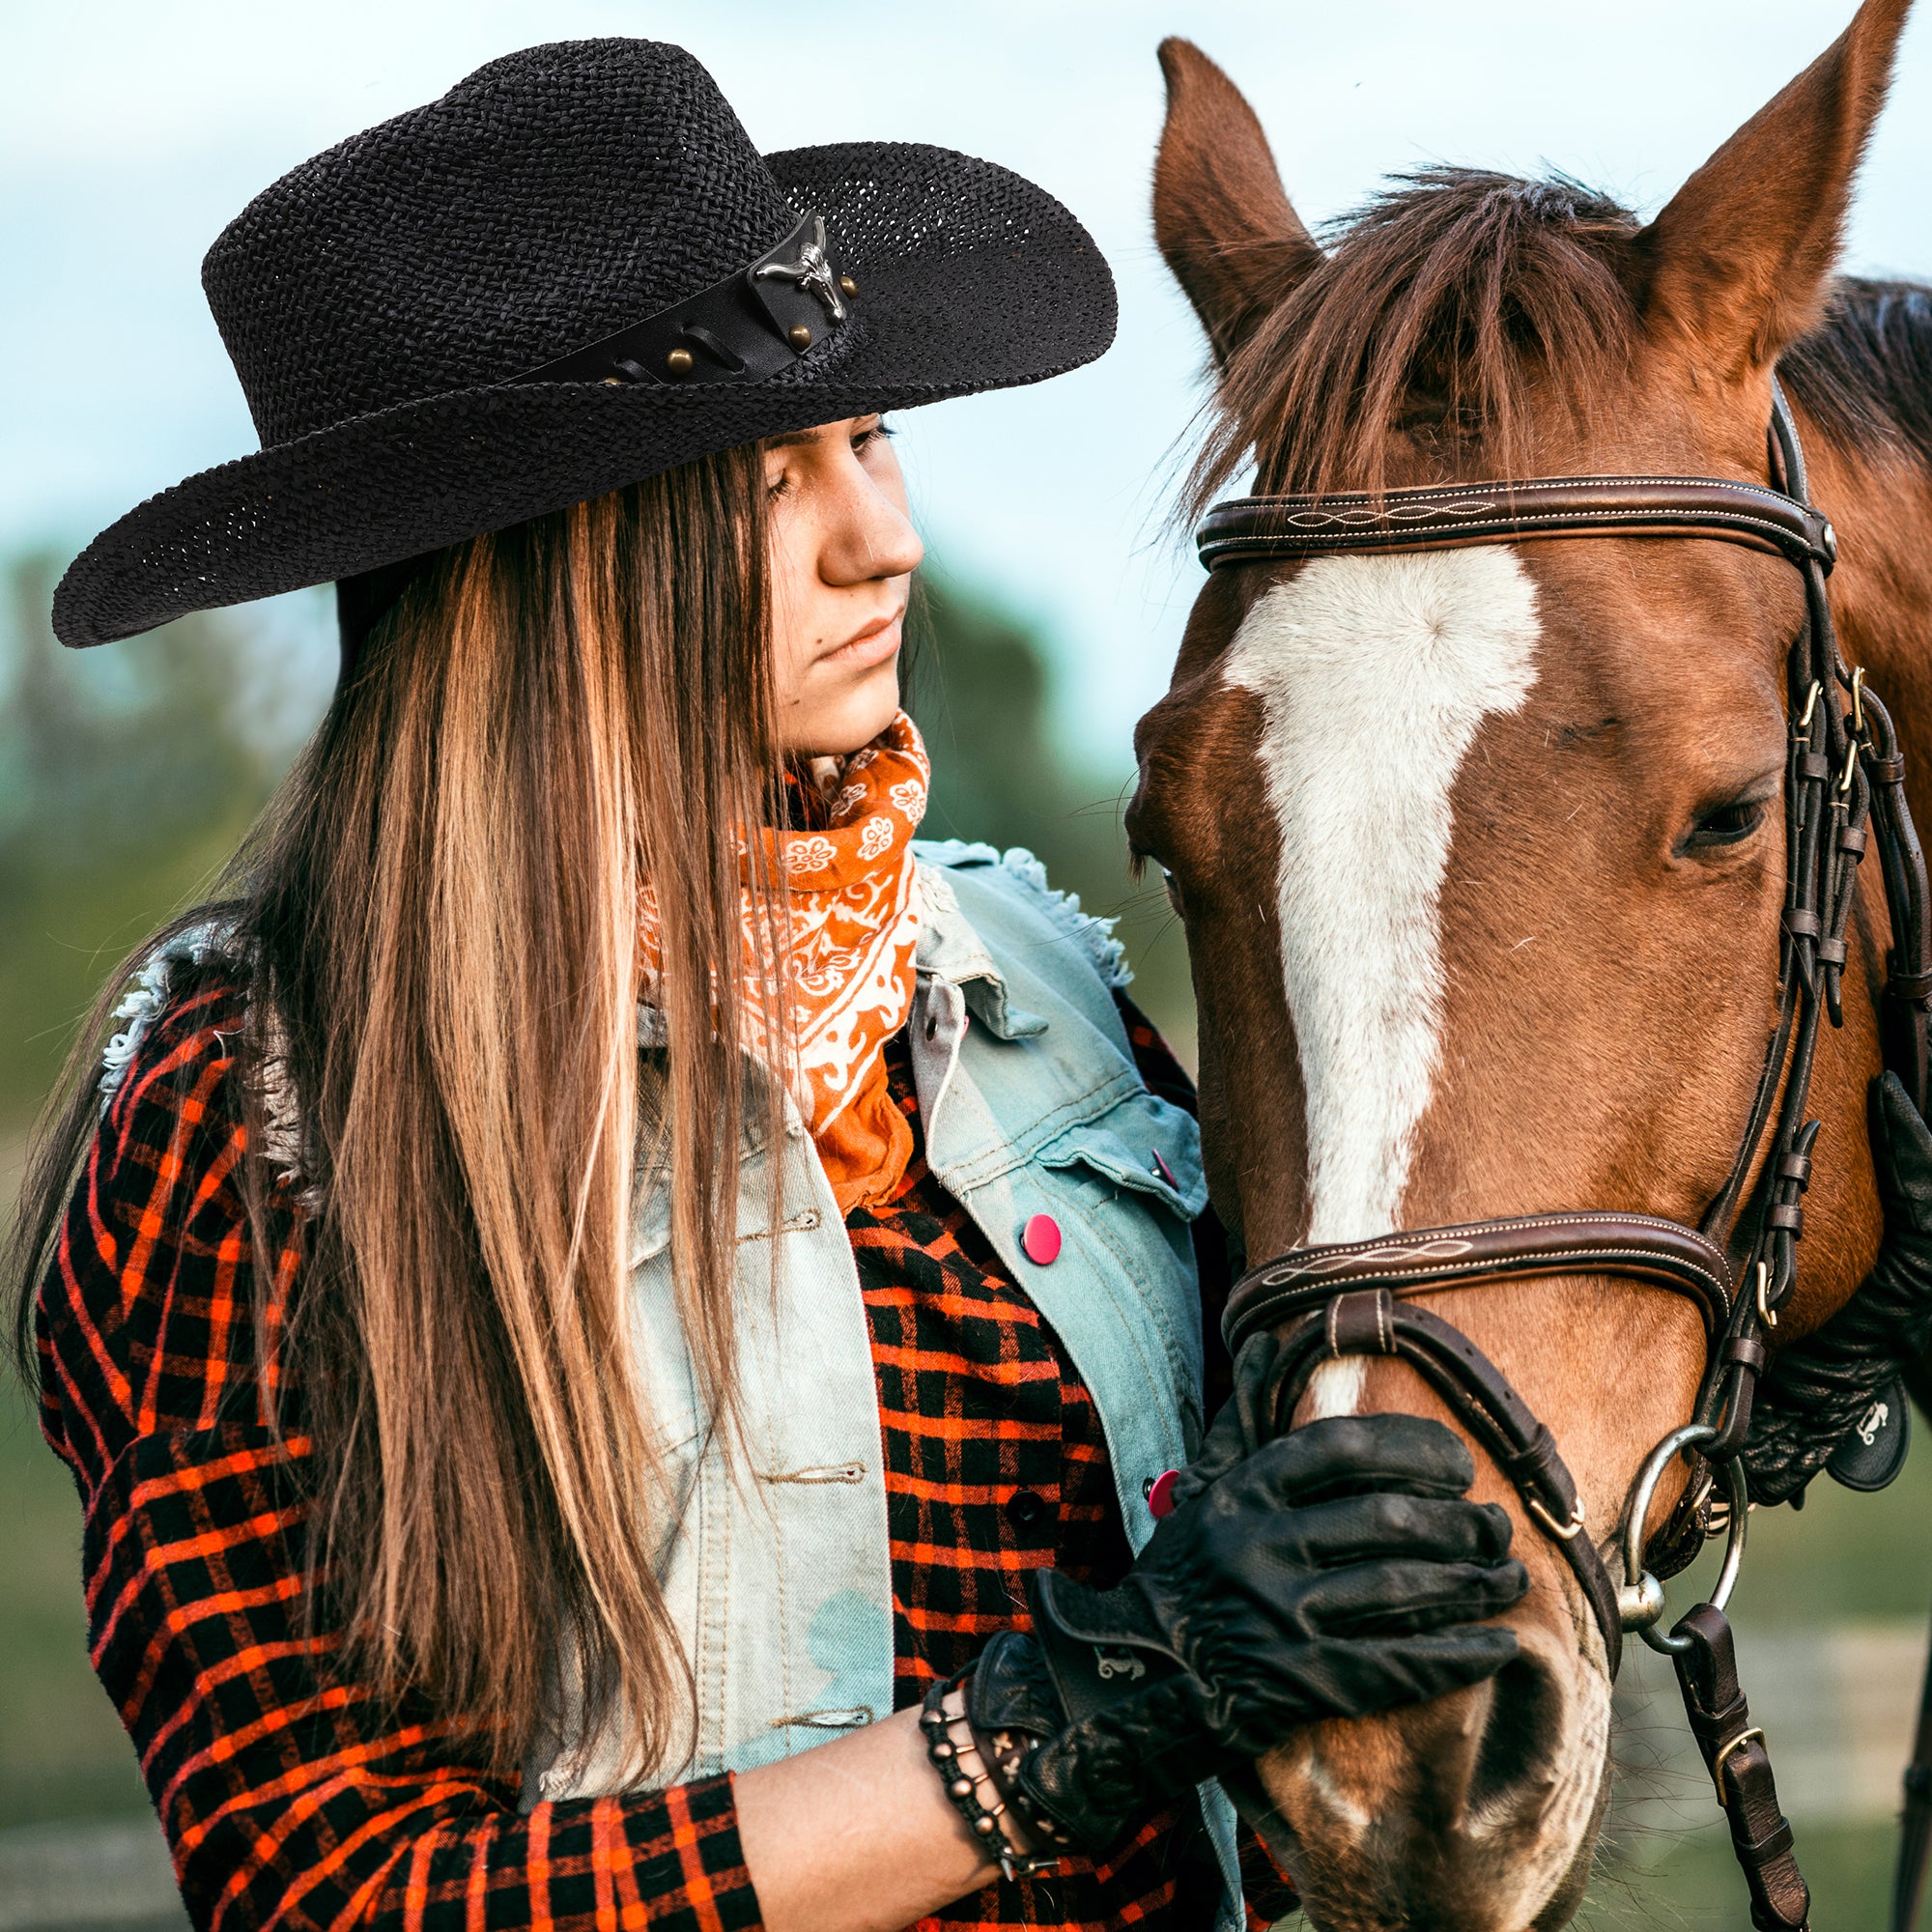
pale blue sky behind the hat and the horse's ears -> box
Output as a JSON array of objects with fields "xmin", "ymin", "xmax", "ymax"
[{"xmin": 0, "ymin": 0, "xmax": 1932, "ymax": 763}]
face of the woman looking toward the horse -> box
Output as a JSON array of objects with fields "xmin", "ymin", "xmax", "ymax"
[{"xmin": 765, "ymin": 415, "xmax": 923, "ymax": 757}]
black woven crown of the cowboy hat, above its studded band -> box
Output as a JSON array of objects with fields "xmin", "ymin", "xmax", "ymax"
[{"xmin": 201, "ymin": 39, "xmax": 798, "ymax": 446}]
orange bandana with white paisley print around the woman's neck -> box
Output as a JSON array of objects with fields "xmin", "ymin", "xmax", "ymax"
[{"xmin": 641, "ymin": 711, "xmax": 931, "ymax": 1213}]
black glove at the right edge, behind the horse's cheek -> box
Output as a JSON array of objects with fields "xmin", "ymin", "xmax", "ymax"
[{"xmin": 1745, "ymin": 1074, "xmax": 1932, "ymax": 1503}]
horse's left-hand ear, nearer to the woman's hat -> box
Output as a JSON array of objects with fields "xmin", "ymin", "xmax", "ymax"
[{"xmin": 1153, "ymin": 39, "xmax": 1321, "ymax": 363}]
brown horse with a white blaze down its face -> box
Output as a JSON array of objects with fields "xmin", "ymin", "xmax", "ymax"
[{"xmin": 1128, "ymin": 0, "xmax": 1932, "ymax": 1932}]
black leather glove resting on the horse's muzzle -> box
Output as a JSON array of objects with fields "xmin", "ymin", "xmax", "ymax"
[{"xmin": 966, "ymin": 1405, "xmax": 1528, "ymax": 1853}]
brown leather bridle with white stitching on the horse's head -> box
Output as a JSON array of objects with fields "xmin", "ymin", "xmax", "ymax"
[{"xmin": 1196, "ymin": 390, "xmax": 1932, "ymax": 1932}]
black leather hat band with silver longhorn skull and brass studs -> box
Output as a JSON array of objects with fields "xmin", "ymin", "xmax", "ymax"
[{"xmin": 508, "ymin": 214, "xmax": 858, "ymax": 388}]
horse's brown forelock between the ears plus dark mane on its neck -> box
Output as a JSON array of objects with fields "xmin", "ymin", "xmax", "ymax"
[{"xmin": 1186, "ymin": 168, "xmax": 1932, "ymax": 512}]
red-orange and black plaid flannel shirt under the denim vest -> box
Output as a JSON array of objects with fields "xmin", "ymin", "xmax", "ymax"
[{"xmin": 39, "ymin": 980, "xmax": 1279, "ymax": 1932}]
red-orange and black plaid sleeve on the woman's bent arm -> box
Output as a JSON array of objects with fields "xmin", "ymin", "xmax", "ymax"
[{"xmin": 37, "ymin": 989, "xmax": 759, "ymax": 1932}]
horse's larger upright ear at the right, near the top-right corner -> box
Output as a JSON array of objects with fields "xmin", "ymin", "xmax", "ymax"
[{"xmin": 1636, "ymin": 0, "xmax": 1911, "ymax": 379}]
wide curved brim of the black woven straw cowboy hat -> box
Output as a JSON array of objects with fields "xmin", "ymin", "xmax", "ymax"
[{"xmin": 54, "ymin": 143, "xmax": 1115, "ymax": 647}]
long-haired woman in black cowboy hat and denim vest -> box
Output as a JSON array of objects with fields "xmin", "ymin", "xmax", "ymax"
[{"xmin": 11, "ymin": 41, "xmax": 1522, "ymax": 1928}]
